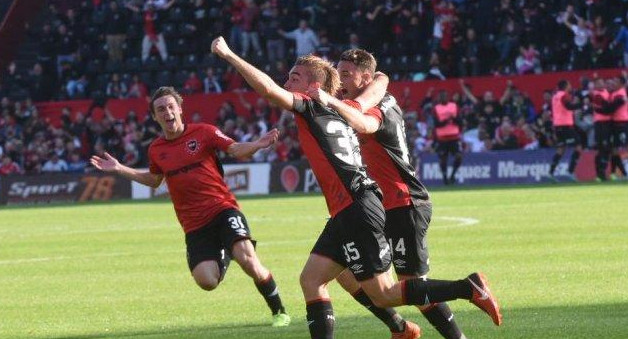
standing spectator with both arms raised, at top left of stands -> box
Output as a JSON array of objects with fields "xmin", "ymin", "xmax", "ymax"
[{"xmin": 126, "ymin": 0, "xmax": 175, "ymax": 61}]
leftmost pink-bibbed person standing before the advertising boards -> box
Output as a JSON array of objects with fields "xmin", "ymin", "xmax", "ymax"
[{"xmin": 434, "ymin": 90, "xmax": 462, "ymax": 185}]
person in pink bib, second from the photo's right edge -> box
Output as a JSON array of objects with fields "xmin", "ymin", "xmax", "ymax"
[{"xmin": 591, "ymin": 78, "xmax": 613, "ymax": 181}]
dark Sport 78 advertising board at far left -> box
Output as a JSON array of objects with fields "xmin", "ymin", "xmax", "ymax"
[{"xmin": 0, "ymin": 173, "xmax": 131, "ymax": 205}]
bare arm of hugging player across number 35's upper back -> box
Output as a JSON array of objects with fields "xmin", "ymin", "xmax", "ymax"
[{"xmin": 306, "ymin": 87, "xmax": 381, "ymax": 134}]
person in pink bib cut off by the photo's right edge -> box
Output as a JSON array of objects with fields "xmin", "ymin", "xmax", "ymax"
[{"xmin": 611, "ymin": 76, "xmax": 628, "ymax": 179}]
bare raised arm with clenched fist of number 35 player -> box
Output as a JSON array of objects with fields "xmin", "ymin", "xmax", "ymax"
[{"xmin": 212, "ymin": 37, "xmax": 294, "ymax": 110}]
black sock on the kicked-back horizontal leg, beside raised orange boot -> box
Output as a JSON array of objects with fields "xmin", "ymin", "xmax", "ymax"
[{"xmin": 401, "ymin": 279, "xmax": 473, "ymax": 305}]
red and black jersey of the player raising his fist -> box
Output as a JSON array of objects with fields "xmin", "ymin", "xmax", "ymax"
[{"xmin": 293, "ymin": 93, "xmax": 377, "ymax": 217}]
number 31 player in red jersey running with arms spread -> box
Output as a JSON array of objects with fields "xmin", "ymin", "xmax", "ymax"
[{"xmin": 90, "ymin": 87, "xmax": 290, "ymax": 327}]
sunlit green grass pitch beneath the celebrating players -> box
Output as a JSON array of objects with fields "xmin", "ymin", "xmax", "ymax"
[{"xmin": 0, "ymin": 184, "xmax": 628, "ymax": 339}]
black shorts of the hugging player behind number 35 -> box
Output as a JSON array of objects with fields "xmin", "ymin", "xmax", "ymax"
[{"xmin": 386, "ymin": 202, "xmax": 432, "ymax": 276}]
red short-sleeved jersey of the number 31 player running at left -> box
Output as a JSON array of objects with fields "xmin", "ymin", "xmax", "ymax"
[{"xmin": 148, "ymin": 124, "xmax": 239, "ymax": 233}]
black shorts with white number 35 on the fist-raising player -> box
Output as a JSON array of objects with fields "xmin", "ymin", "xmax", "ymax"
[{"xmin": 311, "ymin": 190, "xmax": 391, "ymax": 281}]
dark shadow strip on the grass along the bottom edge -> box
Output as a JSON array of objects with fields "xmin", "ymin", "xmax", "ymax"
[{"xmin": 48, "ymin": 304, "xmax": 628, "ymax": 339}]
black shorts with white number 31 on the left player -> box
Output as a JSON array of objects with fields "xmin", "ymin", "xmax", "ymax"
[{"xmin": 185, "ymin": 209, "xmax": 255, "ymax": 279}]
